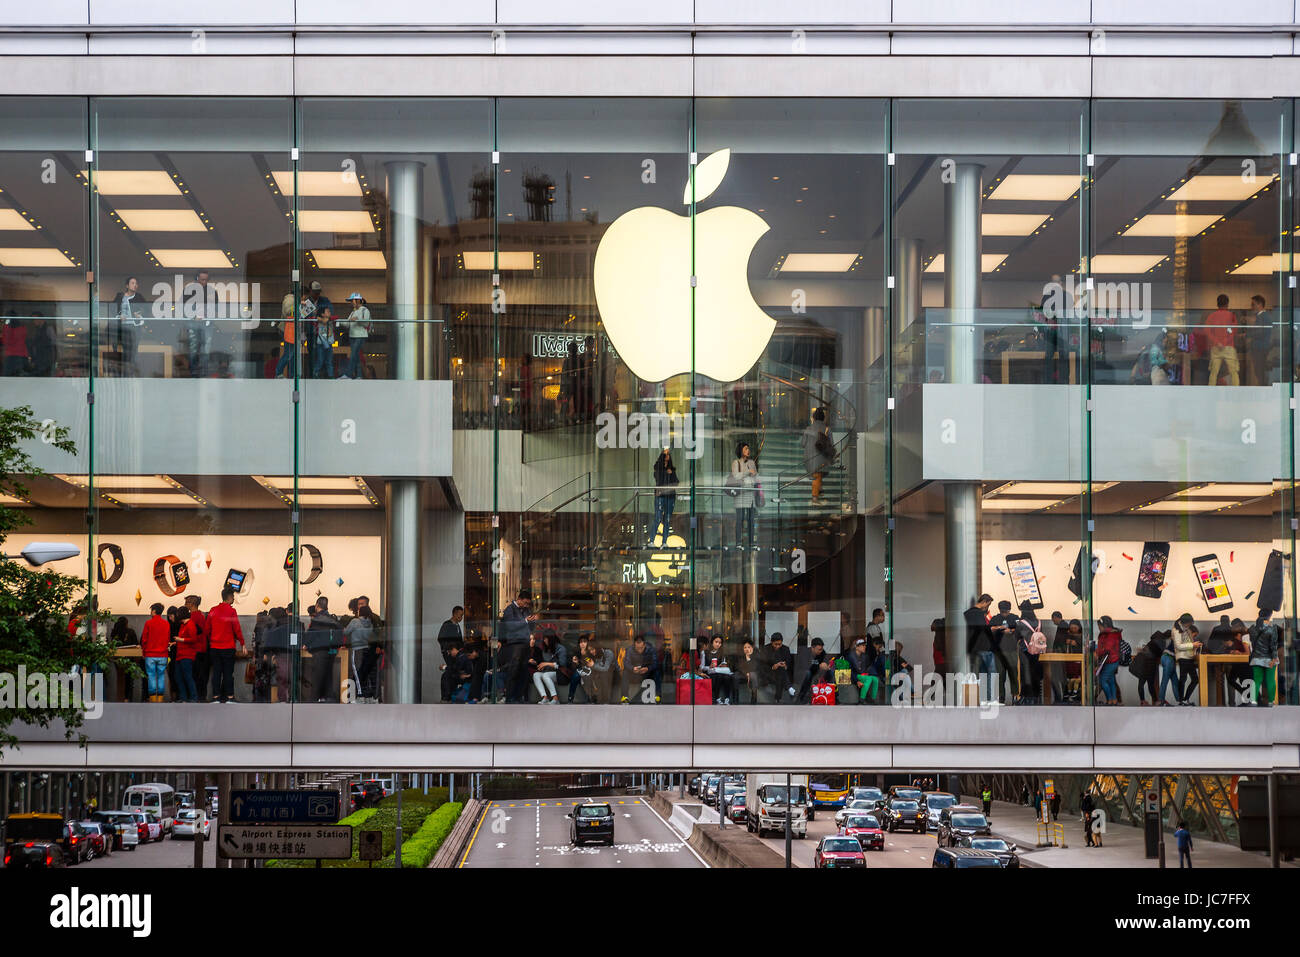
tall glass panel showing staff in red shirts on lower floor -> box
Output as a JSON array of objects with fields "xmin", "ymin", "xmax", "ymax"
[{"xmin": 90, "ymin": 99, "xmax": 298, "ymax": 701}]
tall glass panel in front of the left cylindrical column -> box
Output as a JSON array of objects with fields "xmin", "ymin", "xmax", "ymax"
[{"xmin": 294, "ymin": 99, "xmax": 494, "ymax": 703}]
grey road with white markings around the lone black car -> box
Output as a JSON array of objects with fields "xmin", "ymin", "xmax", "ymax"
[{"xmin": 460, "ymin": 797, "xmax": 706, "ymax": 867}]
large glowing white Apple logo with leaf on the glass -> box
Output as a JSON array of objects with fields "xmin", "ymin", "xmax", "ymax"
[{"xmin": 593, "ymin": 150, "xmax": 776, "ymax": 382}]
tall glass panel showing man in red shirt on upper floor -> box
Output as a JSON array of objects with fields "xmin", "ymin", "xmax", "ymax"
[{"xmin": 1092, "ymin": 100, "xmax": 1291, "ymax": 705}]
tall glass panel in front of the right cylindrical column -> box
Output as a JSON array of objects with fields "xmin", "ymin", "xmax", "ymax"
[{"xmin": 888, "ymin": 100, "xmax": 1088, "ymax": 705}]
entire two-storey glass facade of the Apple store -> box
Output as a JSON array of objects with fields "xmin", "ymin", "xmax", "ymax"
[{"xmin": 0, "ymin": 98, "xmax": 1300, "ymax": 706}]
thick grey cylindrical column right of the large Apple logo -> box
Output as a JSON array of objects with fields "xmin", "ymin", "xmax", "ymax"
[{"xmin": 944, "ymin": 163, "xmax": 984, "ymax": 671}]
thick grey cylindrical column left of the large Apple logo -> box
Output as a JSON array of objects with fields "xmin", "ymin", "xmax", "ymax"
[{"xmin": 382, "ymin": 160, "xmax": 424, "ymax": 705}]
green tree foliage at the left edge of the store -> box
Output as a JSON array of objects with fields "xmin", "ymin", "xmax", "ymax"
[{"xmin": 0, "ymin": 406, "xmax": 113, "ymax": 750}]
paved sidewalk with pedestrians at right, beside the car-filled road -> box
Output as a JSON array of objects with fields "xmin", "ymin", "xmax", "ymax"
[{"xmin": 971, "ymin": 801, "xmax": 1297, "ymax": 869}]
